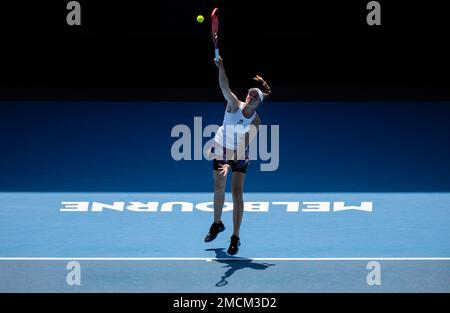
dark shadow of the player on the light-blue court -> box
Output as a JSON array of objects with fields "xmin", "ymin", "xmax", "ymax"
[{"xmin": 205, "ymin": 248, "xmax": 275, "ymax": 287}]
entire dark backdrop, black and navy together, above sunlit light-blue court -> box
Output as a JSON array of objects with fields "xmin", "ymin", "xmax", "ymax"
[{"xmin": 0, "ymin": 0, "xmax": 450, "ymax": 191}]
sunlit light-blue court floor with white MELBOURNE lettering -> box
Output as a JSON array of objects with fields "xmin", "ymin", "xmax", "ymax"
[{"xmin": 0, "ymin": 192, "xmax": 450, "ymax": 292}]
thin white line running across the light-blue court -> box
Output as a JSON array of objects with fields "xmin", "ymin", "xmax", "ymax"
[{"xmin": 0, "ymin": 257, "xmax": 450, "ymax": 261}]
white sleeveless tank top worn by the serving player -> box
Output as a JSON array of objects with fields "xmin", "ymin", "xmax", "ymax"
[{"xmin": 214, "ymin": 102, "xmax": 256, "ymax": 149}]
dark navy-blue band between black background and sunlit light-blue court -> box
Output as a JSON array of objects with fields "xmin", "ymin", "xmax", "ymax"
[{"xmin": 0, "ymin": 101, "xmax": 450, "ymax": 192}]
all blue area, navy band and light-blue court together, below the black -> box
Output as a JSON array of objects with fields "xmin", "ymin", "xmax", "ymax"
[{"xmin": 0, "ymin": 102, "xmax": 450, "ymax": 292}]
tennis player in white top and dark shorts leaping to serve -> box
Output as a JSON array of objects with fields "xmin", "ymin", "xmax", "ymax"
[{"xmin": 205, "ymin": 56, "xmax": 271, "ymax": 255}]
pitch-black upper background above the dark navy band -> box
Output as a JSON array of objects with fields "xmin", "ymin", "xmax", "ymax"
[{"xmin": 0, "ymin": 0, "xmax": 450, "ymax": 100}]
